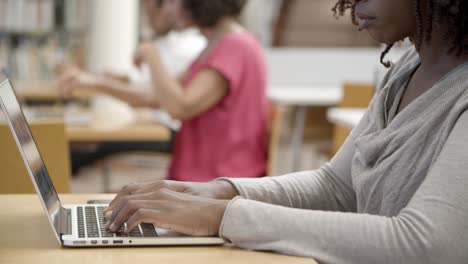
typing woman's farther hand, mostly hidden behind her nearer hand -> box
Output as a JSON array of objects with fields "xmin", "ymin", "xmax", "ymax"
[{"xmin": 104, "ymin": 180, "xmax": 238, "ymax": 218}]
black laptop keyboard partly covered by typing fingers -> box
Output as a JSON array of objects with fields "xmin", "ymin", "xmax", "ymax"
[{"xmin": 77, "ymin": 206, "xmax": 158, "ymax": 238}]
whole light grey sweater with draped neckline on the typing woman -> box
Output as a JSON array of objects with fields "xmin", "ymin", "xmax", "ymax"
[{"xmin": 220, "ymin": 49, "xmax": 468, "ymax": 264}]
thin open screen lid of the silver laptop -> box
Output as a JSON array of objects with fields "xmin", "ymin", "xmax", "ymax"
[{"xmin": 0, "ymin": 73, "xmax": 62, "ymax": 241}]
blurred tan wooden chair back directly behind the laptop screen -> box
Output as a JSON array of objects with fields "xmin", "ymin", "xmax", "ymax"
[{"xmin": 0, "ymin": 120, "xmax": 70, "ymax": 194}]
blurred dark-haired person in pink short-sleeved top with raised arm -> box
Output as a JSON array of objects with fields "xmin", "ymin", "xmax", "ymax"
[{"xmin": 135, "ymin": 0, "xmax": 267, "ymax": 182}]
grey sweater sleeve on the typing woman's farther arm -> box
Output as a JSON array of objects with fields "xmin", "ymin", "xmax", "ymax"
[{"xmin": 218, "ymin": 104, "xmax": 369, "ymax": 211}]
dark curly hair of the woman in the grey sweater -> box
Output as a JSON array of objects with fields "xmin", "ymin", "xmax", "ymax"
[{"xmin": 332, "ymin": 0, "xmax": 468, "ymax": 67}]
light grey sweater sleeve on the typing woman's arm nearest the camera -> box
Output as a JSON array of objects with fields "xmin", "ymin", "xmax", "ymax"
[{"xmin": 220, "ymin": 110, "xmax": 468, "ymax": 264}]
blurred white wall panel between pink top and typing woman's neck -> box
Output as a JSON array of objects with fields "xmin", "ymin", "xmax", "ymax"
[{"xmin": 266, "ymin": 48, "xmax": 405, "ymax": 88}]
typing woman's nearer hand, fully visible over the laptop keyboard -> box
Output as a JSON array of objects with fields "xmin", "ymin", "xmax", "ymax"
[{"xmin": 106, "ymin": 189, "xmax": 229, "ymax": 236}]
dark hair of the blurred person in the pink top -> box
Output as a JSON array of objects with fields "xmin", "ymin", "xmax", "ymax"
[{"xmin": 183, "ymin": 0, "xmax": 247, "ymax": 27}]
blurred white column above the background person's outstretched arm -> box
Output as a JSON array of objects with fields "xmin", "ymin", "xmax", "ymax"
[{"xmin": 88, "ymin": 0, "xmax": 139, "ymax": 73}]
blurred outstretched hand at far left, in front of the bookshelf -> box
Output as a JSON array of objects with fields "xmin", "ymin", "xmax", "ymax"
[{"xmin": 56, "ymin": 66, "xmax": 100, "ymax": 97}]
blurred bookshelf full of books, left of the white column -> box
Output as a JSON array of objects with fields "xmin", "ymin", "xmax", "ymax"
[{"xmin": 0, "ymin": 0, "xmax": 89, "ymax": 82}]
